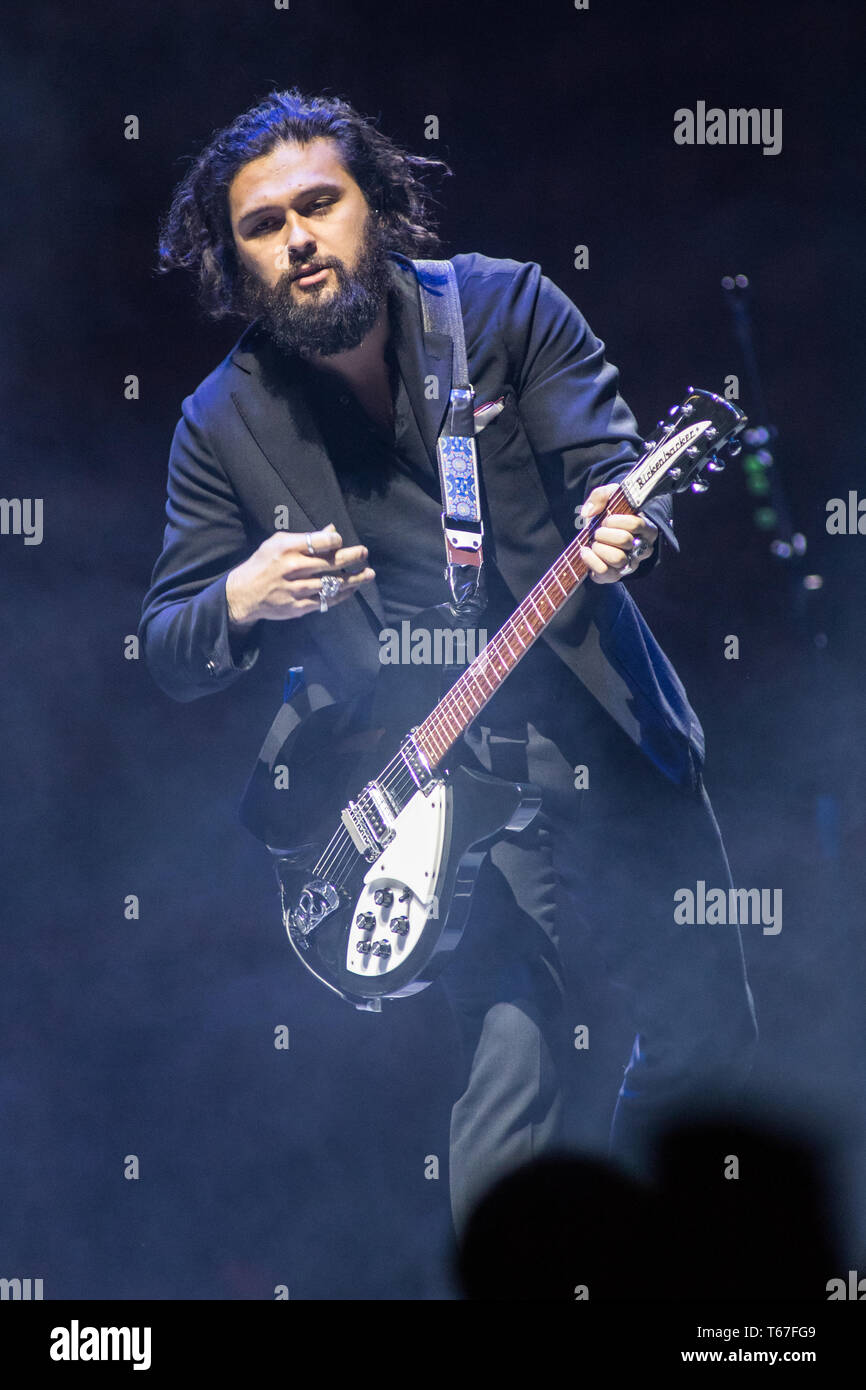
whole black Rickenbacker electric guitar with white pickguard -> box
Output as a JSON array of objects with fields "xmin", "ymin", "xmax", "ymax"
[{"xmin": 268, "ymin": 386, "xmax": 746, "ymax": 1012}]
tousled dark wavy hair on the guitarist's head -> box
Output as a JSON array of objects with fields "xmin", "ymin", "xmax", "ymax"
[{"xmin": 157, "ymin": 88, "xmax": 452, "ymax": 318}]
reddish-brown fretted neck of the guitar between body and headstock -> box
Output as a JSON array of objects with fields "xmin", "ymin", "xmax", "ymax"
[{"xmin": 413, "ymin": 488, "xmax": 635, "ymax": 767}]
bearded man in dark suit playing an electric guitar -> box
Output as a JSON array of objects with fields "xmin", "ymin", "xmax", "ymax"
[{"xmin": 142, "ymin": 90, "xmax": 756, "ymax": 1230}]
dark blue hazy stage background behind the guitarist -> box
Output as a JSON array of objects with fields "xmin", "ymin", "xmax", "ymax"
[{"xmin": 0, "ymin": 0, "xmax": 866, "ymax": 1300}]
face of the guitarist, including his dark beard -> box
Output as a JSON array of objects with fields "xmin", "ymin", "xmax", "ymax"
[{"xmin": 228, "ymin": 139, "xmax": 389, "ymax": 356}]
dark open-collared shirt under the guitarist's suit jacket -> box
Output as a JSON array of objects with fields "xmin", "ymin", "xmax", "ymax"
[{"xmin": 294, "ymin": 343, "xmax": 600, "ymax": 730}]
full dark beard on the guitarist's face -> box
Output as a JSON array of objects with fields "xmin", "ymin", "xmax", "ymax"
[{"xmin": 240, "ymin": 217, "xmax": 391, "ymax": 357}]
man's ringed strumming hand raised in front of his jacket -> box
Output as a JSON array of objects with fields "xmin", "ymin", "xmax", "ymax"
[{"xmin": 225, "ymin": 523, "xmax": 375, "ymax": 632}]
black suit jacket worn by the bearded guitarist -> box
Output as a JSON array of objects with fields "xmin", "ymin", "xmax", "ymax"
[{"xmin": 139, "ymin": 253, "xmax": 703, "ymax": 787}]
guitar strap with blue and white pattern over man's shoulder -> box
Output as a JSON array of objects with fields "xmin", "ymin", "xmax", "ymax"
[{"xmin": 413, "ymin": 260, "xmax": 487, "ymax": 624}]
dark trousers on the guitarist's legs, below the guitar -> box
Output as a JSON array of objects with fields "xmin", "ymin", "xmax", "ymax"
[{"xmin": 441, "ymin": 699, "xmax": 758, "ymax": 1234}]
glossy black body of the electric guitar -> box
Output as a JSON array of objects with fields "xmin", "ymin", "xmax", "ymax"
[{"xmin": 268, "ymin": 612, "xmax": 541, "ymax": 1012}]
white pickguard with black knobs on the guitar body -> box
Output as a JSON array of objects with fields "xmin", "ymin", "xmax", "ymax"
[{"xmin": 346, "ymin": 783, "xmax": 448, "ymax": 979}]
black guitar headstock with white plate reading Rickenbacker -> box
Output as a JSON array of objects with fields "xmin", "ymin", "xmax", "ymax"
[{"xmin": 620, "ymin": 386, "xmax": 746, "ymax": 512}]
